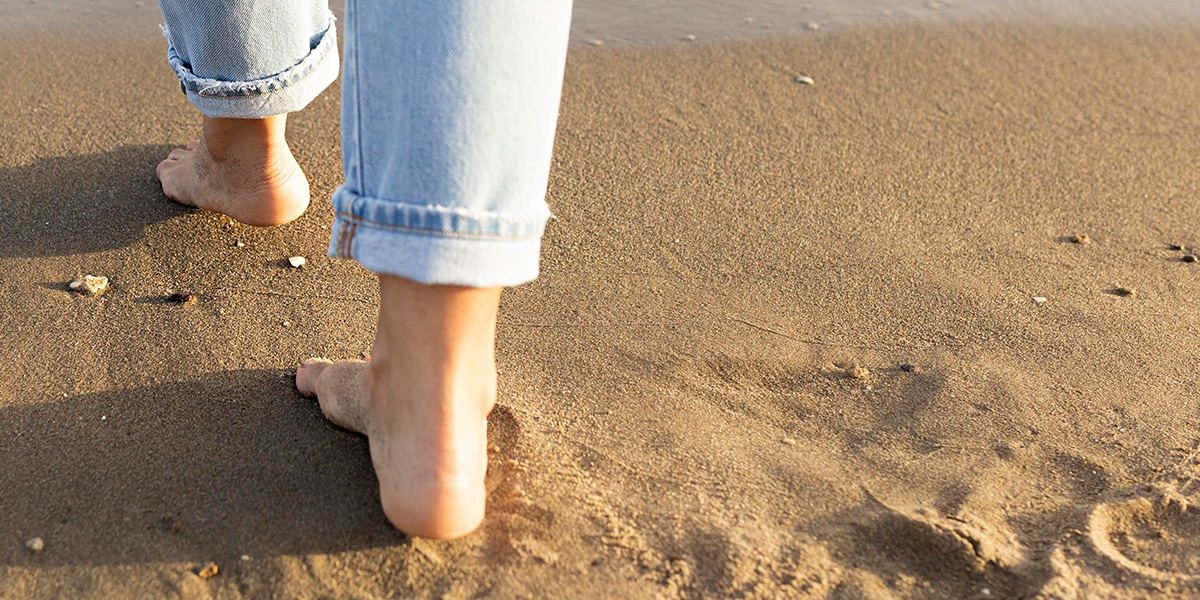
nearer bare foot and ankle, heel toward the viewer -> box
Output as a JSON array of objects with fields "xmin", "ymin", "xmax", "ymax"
[{"xmin": 296, "ymin": 275, "xmax": 500, "ymax": 539}]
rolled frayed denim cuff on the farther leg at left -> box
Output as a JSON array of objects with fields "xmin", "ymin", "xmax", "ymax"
[{"xmin": 163, "ymin": 13, "xmax": 338, "ymax": 119}]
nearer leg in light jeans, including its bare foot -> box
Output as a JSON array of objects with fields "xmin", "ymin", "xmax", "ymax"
[{"xmin": 296, "ymin": 0, "xmax": 570, "ymax": 538}]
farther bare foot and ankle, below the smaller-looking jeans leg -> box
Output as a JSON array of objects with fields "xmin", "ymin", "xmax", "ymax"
[{"xmin": 155, "ymin": 114, "xmax": 308, "ymax": 227}]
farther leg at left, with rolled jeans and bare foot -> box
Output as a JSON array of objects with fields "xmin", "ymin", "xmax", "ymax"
[{"xmin": 156, "ymin": 0, "xmax": 337, "ymax": 226}]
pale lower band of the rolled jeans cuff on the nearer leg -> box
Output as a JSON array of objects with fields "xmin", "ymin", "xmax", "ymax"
[{"xmin": 329, "ymin": 216, "xmax": 541, "ymax": 288}]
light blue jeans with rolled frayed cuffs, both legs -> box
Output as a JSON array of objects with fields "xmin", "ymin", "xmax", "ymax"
[{"xmin": 160, "ymin": 0, "xmax": 571, "ymax": 287}]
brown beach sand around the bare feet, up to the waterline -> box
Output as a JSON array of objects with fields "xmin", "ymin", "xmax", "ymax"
[{"xmin": 0, "ymin": 12, "xmax": 1200, "ymax": 598}]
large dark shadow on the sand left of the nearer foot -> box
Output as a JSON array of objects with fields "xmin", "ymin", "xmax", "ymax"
[{"xmin": 0, "ymin": 371, "xmax": 403, "ymax": 566}]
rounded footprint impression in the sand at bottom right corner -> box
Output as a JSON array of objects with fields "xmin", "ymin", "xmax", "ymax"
[{"xmin": 1088, "ymin": 485, "xmax": 1200, "ymax": 587}]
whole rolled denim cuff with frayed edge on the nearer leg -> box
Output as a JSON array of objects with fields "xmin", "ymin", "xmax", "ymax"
[{"xmin": 329, "ymin": 186, "xmax": 550, "ymax": 288}]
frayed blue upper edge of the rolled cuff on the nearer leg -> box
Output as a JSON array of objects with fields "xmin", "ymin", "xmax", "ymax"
[{"xmin": 331, "ymin": 186, "xmax": 550, "ymax": 240}]
